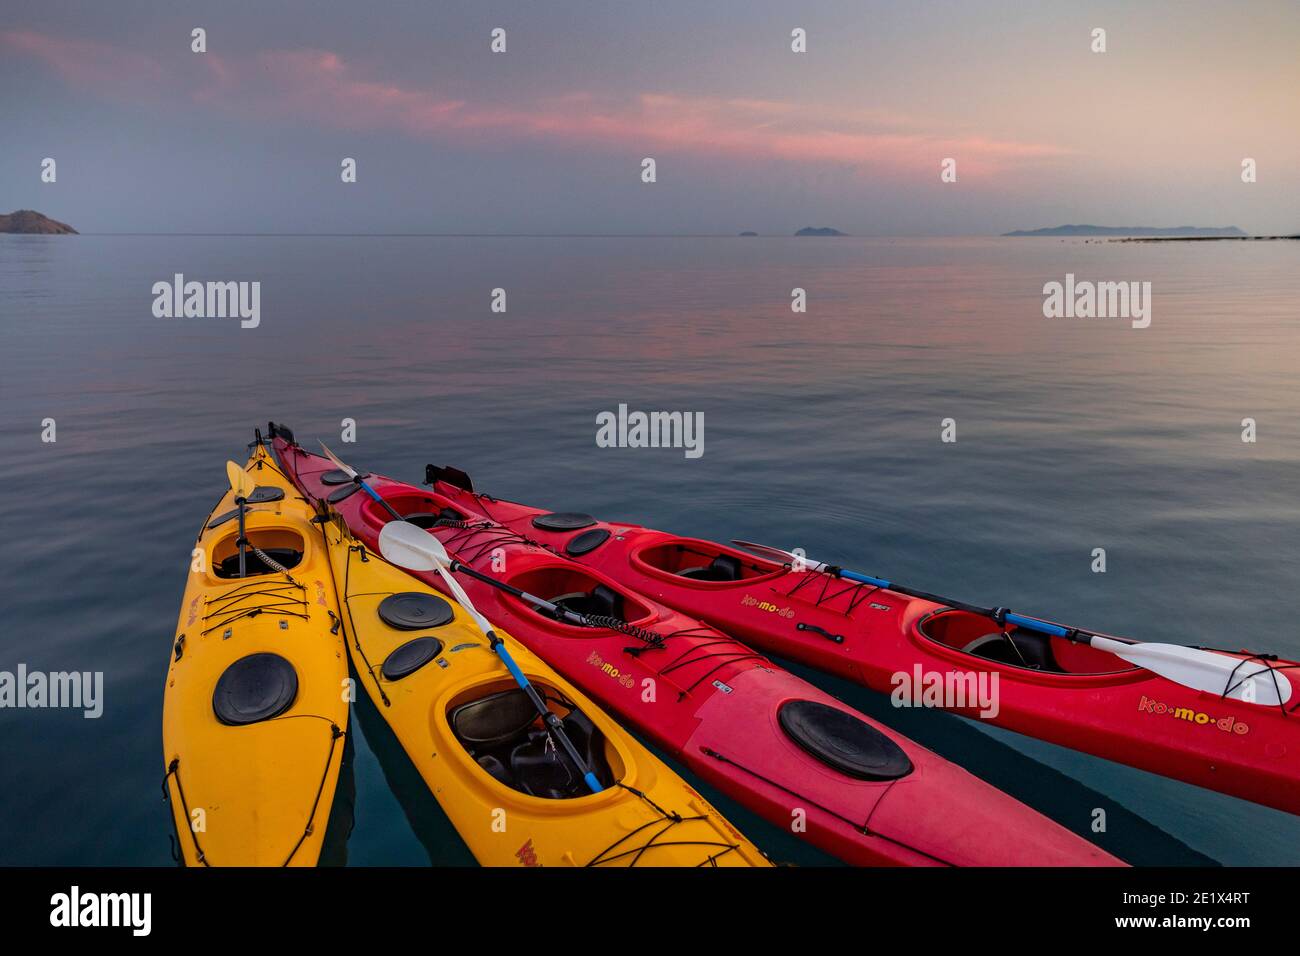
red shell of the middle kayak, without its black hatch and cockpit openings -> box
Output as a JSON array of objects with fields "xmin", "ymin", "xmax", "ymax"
[{"xmin": 273, "ymin": 431, "xmax": 1119, "ymax": 865}]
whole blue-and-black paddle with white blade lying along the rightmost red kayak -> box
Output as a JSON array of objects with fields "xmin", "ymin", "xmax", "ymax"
[{"xmin": 732, "ymin": 540, "xmax": 1291, "ymax": 706}]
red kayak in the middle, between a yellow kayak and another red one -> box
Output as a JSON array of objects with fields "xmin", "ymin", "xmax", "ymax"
[{"xmin": 272, "ymin": 425, "xmax": 1122, "ymax": 866}]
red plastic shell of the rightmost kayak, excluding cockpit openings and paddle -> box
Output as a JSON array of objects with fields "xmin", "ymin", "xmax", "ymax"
[{"xmin": 436, "ymin": 502, "xmax": 1300, "ymax": 813}]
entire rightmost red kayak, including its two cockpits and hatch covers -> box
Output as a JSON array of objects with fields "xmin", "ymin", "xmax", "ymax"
[{"xmin": 416, "ymin": 466, "xmax": 1300, "ymax": 813}]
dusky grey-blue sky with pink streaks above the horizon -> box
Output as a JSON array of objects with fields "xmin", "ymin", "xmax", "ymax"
[{"xmin": 0, "ymin": 0, "xmax": 1300, "ymax": 235}]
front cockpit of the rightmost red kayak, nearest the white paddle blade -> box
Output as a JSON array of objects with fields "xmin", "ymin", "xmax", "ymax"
[{"xmin": 917, "ymin": 609, "xmax": 1135, "ymax": 674}]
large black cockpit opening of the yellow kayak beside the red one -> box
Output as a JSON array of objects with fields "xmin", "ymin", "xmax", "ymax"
[{"xmin": 447, "ymin": 678, "xmax": 624, "ymax": 800}]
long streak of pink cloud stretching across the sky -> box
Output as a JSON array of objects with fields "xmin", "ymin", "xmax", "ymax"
[{"xmin": 0, "ymin": 31, "xmax": 1069, "ymax": 177}]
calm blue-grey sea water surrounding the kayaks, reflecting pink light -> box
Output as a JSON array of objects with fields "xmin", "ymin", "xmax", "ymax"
[{"xmin": 0, "ymin": 235, "xmax": 1300, "ymax": 865}]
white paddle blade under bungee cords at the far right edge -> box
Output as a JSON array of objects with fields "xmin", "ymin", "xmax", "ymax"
[{"xmin": 1089, "ymin": 637, "xmax": 1291, "ymax": 708}]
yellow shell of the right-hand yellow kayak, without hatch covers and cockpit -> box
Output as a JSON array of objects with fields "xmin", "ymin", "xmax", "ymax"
[{"xmin": 321, "ymin": 514, "xmax": 770, "ymax": 866}]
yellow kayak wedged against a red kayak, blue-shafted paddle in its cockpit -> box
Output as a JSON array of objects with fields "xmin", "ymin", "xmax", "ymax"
[{"xmin": 320, "ymin": 515, "xmax": 770, "ymax": 866}]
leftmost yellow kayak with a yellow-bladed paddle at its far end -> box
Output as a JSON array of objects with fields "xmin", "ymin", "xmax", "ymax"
[{"xmin": 163, "ymin": 444, "xmax": 350, "ymax": 866}]
